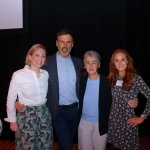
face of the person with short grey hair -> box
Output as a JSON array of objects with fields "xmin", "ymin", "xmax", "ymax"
[{"xmin": 84, "ymin": 56, "xmax": 100, "ymax": 76}]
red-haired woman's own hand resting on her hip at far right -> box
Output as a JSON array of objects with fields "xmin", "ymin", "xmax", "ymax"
[{"xmin": 127, "ymin": 117, "xmax": 145, "ymax": 127}]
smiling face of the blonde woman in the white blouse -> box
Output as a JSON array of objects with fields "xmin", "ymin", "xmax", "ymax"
[{"xmin": 29, "ymin": 48, "xmax": 46, "ymax": 70}]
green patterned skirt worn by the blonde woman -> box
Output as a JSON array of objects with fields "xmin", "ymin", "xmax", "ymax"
[{"xmin": 16, "ymin": 105, "xmax": 54, "ymax": 150}]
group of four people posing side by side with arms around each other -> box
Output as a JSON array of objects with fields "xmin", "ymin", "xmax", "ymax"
[{"xmin": 5, "ymin": 29, "xmax": 150, "ymax": 150}]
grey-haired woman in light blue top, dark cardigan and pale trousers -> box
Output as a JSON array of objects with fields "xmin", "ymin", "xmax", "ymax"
[{"xmin": 78, "ymin": 51, "xmax": 112, "ymax": 150}]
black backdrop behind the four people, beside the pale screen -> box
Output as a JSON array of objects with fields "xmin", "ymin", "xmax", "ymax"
[{"xmin": 0, "ymin": 0, "xmax": 150, "ymax": 140}]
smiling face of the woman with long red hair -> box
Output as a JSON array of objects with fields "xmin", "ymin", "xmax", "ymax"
[{"xmin": 114, "ymin": 52, "xmax": 128, "ymax": 76}]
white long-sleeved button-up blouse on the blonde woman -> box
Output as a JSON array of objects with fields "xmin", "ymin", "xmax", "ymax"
[{"xmin": 4, "ymin": 65, "xmax": 49, "ymax": 122}]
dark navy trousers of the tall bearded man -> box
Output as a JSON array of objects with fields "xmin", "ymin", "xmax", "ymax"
[{"xmin": 52, "ymin": 106, "xmax": 78, "ymax": 150}]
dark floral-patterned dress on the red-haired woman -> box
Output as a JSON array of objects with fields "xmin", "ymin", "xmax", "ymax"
[{"xmin": 107, "ymin": 75, "xmax": 150, "ymax": 150}]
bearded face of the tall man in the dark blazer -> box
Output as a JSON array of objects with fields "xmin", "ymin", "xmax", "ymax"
[{"xmin": 56, "ymin": 34, "xmax": 73, "ymax": 58}]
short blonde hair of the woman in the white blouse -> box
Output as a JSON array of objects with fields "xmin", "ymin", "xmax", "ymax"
[{"xmin": 25, "ymin": 44, "xmax": 46, "ymax": 66}]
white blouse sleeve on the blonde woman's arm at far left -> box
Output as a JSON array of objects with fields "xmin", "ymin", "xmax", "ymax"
[{"xmin": 4, "ymin": 73, "xmax": 19, "ymax": 122}]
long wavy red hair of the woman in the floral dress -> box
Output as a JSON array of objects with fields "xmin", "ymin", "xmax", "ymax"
[{"xmin": 107, "ymin": 49, "xmax": 137, "ymax": 91}]
